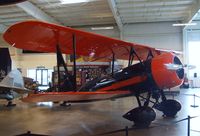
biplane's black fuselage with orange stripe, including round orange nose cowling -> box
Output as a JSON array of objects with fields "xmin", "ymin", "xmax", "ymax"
[{"xmin": 80, "ymin": 53, "xmax": 184, "ymax": 93}]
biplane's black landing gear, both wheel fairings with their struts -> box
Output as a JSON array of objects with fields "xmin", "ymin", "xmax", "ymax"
[{"xmin": 123, "ymin": 90, "xmax": 181, "ymax": 128}]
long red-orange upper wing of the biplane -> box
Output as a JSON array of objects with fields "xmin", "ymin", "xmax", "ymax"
[{"xmin": 4, "ymin": 21, "xmax": 160, "ymax": 60}]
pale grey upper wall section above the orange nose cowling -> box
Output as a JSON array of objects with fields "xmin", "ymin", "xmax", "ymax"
[{"xmin": 123, "ymin": 22, "xmax": 183, "ymax": 51}]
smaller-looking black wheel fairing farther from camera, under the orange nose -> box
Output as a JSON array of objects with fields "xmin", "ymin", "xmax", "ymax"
[{"xmin": 155, "ymin": 99, "xmax": 181, "ymax": 117}]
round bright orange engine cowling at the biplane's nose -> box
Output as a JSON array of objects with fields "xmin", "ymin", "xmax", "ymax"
[{"xmin": 151, "ymin": 53, "xmax": 184, "ymax": 89}]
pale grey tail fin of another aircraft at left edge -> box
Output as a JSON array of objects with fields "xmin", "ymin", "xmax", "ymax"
[{"xmin": 0, "ymin": 70, "xmax": 27, "ymax": 93}]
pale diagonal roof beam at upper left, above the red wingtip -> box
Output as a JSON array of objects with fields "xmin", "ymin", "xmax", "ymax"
[{"xmin": 16, "ymin": 1, "xmax": 61, "ymax": 24}]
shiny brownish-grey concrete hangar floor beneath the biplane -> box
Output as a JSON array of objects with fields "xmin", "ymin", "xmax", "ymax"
[{"xmin": 0, "ymin": 89, "xmax": 200, "ymax": 136}]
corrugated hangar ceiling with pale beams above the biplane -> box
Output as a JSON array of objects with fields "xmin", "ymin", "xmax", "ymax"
[{"xmin": 0, "ymin": 0, "xmax": 200, "ymax": 32}]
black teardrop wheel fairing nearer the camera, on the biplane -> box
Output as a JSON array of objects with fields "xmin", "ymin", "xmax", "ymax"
[{"xmin": 123, "ymin": 106, "xmax": 156, "ymax": 128}]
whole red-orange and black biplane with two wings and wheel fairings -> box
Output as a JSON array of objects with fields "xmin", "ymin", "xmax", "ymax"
[{"xmin": 4, "ymin": 21, "xmax": 184, "ymax": 126}]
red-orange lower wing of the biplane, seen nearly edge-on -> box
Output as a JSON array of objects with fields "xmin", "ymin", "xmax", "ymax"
[{"xmin": 21, "ymin": 91, "xmax": 132, "ymax": 103}]
